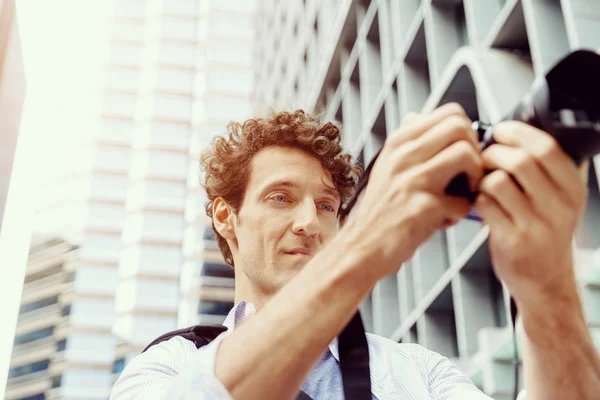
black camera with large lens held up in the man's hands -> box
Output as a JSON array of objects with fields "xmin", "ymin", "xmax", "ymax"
[{"xmin": 446, "ymin": 50, "xmax": 600, "ymax": 209}]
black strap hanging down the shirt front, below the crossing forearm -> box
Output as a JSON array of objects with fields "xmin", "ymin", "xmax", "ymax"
[{"xmin": 338, "ymin": 311, "xmax": 372, "ymax": 400}]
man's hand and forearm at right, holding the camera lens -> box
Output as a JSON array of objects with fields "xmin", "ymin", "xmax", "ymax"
[{"xmin": 475, "ymin": 121, "xmax": 600, "ymax": 400}]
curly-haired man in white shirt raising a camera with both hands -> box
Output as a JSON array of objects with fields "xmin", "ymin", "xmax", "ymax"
[{"xmin": 111, "ymin": 104, "xmax": 600, "ymax": 400}]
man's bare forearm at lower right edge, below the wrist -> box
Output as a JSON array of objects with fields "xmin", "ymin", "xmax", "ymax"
[{"xmin": 519, "ymin": 285, "xmax": 600, "ymax": 400}]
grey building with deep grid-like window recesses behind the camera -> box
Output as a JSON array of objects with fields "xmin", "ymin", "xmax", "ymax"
[{"xmin": 254, "ymin": 0, "xmax": 600, "ymax": 399}]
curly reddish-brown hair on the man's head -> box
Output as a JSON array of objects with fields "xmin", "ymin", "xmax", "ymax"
[{"xmin": 200, "ymin": 110, "xmax": 362, "ymax": 267}]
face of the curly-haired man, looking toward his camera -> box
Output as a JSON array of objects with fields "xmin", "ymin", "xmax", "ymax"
[{"xmin": 232, "ymin": 146, "xmax": 340, "ymax": 293}]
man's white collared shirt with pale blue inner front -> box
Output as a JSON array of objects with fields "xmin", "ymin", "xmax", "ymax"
[{"xmin": 110, "ymin": 302, "xmax": 490, "ymax": 400}]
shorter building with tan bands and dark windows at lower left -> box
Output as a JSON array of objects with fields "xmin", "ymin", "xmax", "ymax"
[{"xmin": 5, "ymin": 236, "xmax": 78, "ymax": 400}]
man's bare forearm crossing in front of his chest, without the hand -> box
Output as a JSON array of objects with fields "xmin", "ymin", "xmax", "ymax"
[{"xmin": 215, "ymin": 230, "xmax": 376, "ymax": 399}]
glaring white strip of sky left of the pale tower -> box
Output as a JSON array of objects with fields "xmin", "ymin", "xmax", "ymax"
[{"xmin": 0, "ymin": 0, "xmax": 112, "ymax": 398}]
